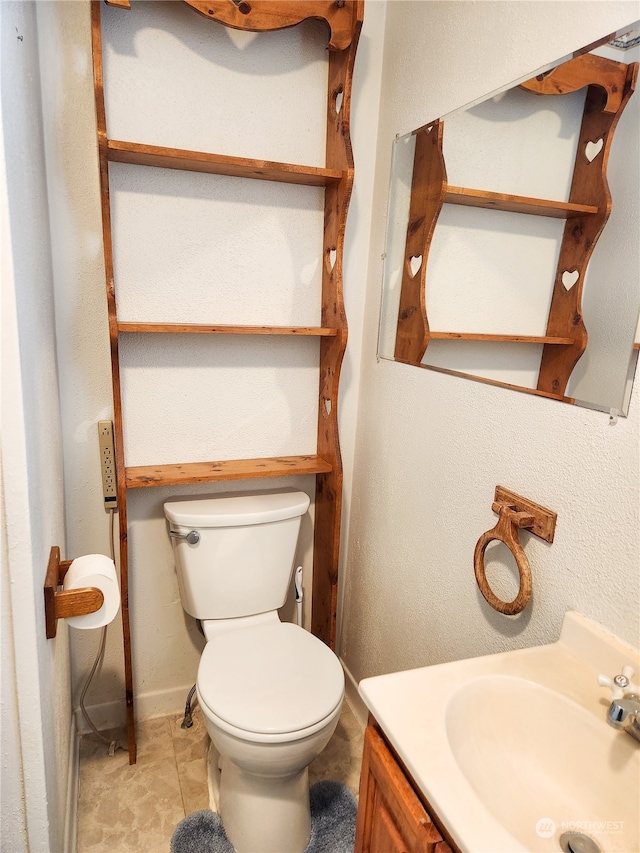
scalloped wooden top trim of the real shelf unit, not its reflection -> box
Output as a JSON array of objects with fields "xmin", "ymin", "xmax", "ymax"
[{"xmin": 107, "ymin": 0, "xmax": 362, "ymax": 50}]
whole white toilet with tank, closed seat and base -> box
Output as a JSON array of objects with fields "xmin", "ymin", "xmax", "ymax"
[{"xmin": 164, "ymin": 489, "xmax": 344, "ymax": 853}]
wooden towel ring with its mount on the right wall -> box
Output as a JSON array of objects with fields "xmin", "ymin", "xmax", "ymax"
[{"xmin": 473, "ymin": 486, "xmax": 557, "ymax": 616}]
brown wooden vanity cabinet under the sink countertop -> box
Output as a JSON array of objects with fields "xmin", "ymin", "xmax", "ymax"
[{"xmin": 355, "ymin": 720, "xmax": 455, "ymax": 853}]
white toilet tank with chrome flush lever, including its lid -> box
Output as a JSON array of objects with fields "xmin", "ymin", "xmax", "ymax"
[{"xmin": 164, "ymin": 489, "xmax": 309, "ymax": 619}]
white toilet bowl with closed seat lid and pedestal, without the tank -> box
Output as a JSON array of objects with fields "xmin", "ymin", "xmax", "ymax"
[{"xmin": 196, "ymin": 614, "xmax": 344, "ymax": 853}]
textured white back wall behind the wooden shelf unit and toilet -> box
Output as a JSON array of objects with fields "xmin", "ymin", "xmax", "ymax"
[{"xmin": 39, "ymin": 2, "xmax": 384, "ymax": 724}]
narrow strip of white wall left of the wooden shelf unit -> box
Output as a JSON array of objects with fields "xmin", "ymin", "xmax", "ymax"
[{"xmin": 37, "ymin": 2, "xmax": 124, "ymax": 732}]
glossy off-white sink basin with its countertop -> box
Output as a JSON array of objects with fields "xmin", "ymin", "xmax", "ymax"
[{"xmin": 360, "ymin": 613, "xmax": 640, "ymax": 853}]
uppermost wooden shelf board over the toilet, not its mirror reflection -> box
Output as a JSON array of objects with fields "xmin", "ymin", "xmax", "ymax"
[{"xmin": 107, "ymin": 139, "xmax": 343, "ymax": 187}]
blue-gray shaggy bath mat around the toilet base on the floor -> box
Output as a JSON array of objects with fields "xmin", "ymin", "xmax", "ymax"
[{"xmin": 171, "ymin": 782, "xmax": 357, "ymax": 853}]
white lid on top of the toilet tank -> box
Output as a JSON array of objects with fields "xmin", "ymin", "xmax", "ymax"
[{"xmin": 164, "ymin": 489, "xmax": 309, "ymax": 528}]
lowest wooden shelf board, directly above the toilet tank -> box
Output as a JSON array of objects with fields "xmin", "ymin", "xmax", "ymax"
[{"xmin": 125, "ymin": 456, "xmax": 332, "ymax": 489}]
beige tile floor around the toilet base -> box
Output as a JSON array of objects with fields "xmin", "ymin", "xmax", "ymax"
[{"xmin": 77, "ymin": 702, "xmax": 363, "ymax": 853}]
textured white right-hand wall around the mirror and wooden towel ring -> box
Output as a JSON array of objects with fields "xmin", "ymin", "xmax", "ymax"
[{"xmin": 342, "ymin": 0, "xmax": 640, "ymax": 680}]
